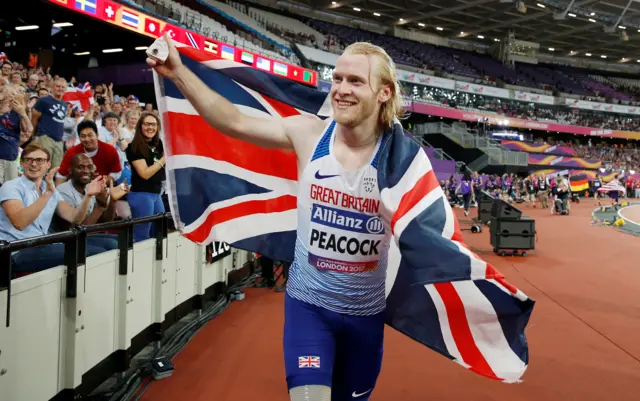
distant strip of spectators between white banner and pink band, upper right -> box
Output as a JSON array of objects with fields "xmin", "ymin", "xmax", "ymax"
[{"xmin": 402, "ymin": 83, "xmax": 640, "ymax": 131}]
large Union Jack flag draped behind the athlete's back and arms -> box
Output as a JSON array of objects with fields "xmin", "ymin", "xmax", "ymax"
[{"xmin": 154, "ymin": 46, "xmax": 534, "ymax": 382}]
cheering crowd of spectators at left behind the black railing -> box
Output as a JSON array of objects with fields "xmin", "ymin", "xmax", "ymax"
[{"xmin": 0, "ymin": 54, "xmax": 166, "ymax": 272}]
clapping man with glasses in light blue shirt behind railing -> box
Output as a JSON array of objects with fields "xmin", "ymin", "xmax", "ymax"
[{"xmin": 0, "ymin": 143, "xmax": 108, "ymax": 272}]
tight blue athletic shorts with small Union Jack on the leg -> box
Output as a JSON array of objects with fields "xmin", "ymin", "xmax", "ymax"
[{"xmin": 284, "ymin": 294, "xmax": 384, "ymax": 401}]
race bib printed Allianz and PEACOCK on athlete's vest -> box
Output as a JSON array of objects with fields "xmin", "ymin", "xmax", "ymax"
[{"xmin": 308, "ymin": 203, "xmax": 384, "ymax": 273}]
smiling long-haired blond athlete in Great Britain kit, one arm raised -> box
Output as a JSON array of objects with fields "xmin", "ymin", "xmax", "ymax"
[{"xmin": 147, "ymin": 35, "xmax": 402, "ymax": 401}]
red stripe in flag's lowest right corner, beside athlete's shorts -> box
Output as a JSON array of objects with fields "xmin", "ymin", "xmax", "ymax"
[{"xmin": 434, "ymin": 283, "xmax": 500, "ymax": 380}]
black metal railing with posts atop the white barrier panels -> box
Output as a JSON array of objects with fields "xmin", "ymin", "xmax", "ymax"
[{"xmin": 0, "ymin": 213, "xmax": 171, "ymax": 327}]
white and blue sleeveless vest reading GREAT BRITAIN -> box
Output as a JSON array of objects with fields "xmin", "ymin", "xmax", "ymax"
[{"xmin": 287, "ymin": 121, "xmax": 391, "ymax": 315}]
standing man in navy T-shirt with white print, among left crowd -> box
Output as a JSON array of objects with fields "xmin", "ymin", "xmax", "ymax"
[{"xmin": 31, "ymin": 78, "xmax": 67, "ymax": 167}]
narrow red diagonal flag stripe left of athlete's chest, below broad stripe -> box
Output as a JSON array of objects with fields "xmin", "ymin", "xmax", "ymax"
[{"xmin": 185, "ymin": 195, "xmax": 298, "ymax": 243}]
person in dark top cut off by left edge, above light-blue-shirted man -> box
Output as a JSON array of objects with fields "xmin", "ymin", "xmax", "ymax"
[{"xmin": 0, "ymin": 86, "xmax": 32, "ymax": 185}]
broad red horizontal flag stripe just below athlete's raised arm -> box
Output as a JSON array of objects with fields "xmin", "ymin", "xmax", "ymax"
[{"xmin": 164, "ymin": 112, "xmax": 298, "ymax": 180}]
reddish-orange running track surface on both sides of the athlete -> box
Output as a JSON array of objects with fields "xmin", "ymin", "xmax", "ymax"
[{"xmin": 142, "ymin": 202, "xmax": 640, "ymax": 401}]
